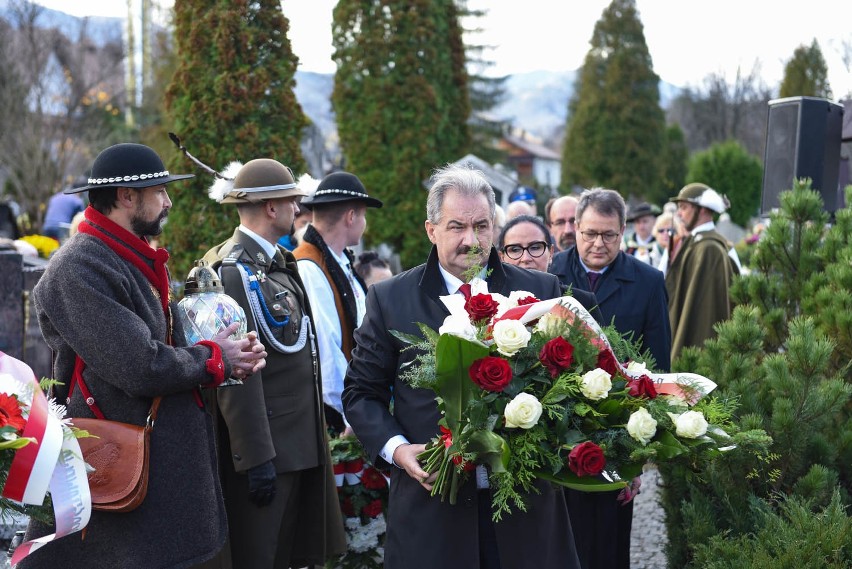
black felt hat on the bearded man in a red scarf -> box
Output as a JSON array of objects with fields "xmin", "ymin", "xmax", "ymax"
[{"xmin": 65, "ymin": 142, "xmax": 195, "ymax": 194}]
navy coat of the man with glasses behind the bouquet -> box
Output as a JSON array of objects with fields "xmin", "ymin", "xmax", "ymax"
[{"xmin": 549, "ymin": 246, "xmax": 672, "ymax": 371}]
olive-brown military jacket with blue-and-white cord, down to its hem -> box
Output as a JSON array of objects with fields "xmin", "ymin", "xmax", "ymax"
[{"xmin": 204, "ymin": 229, "xmax": 326, "ymax": 473}]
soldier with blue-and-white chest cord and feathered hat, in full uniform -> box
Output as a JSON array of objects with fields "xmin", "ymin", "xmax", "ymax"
[{"xmin": 205, "ymin": 158, "xmax": 346, "ymax": 568}]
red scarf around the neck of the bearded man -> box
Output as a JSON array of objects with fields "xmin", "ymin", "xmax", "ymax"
[{"xmin": 78, "ymin": 206, "xmax": 172, "ymax": 328}]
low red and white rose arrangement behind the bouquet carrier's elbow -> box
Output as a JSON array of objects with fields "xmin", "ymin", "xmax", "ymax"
[{"xmin": 326, "ymin": 436, "xmax": 388, "ymax": 569}]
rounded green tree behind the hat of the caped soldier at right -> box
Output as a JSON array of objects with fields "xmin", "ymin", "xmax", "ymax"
[{"xmin": 686, "ymin": 140, "xmax": 763, "ymax": 227}]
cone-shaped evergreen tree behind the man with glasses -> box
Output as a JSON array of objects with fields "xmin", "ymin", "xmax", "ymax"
[{"xmin": 562, "ymin": 0, "xmax": 666, "ymax": 198}]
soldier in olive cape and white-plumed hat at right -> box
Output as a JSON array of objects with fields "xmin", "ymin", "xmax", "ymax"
[{"xmin": 666, "ymin": 183, "xmax": 739, "ymax": 360}]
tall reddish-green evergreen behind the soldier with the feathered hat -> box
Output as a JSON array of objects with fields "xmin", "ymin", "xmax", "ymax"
[{"xmin": 163, "ymin": 0, "xmax": 307, "ymax": 280}]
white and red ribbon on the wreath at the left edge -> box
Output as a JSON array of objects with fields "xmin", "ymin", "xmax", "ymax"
[{"xmin": 0, "ymin": 352, "xmax": 92, "ymax": 566}]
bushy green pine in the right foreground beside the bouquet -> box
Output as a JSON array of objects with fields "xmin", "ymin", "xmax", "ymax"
[{"xmin": 660, "ymin": 182, "xmax": 852, "ymax": 567}]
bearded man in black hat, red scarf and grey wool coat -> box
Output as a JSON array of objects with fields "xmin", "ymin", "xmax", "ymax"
[{"xmin": 18, "ymin": 143, "xmax": 266, "ymax": 569}]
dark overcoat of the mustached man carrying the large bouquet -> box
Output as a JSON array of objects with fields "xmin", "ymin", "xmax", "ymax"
[{"xmin": 343, "ymin": 247, "xmax": 579, "ymax": 569}]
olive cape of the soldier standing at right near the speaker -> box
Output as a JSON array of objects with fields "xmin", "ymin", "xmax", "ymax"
[{"xmin": 666, "ymin": 231, "xmax": 739, "ymax": 359}]
